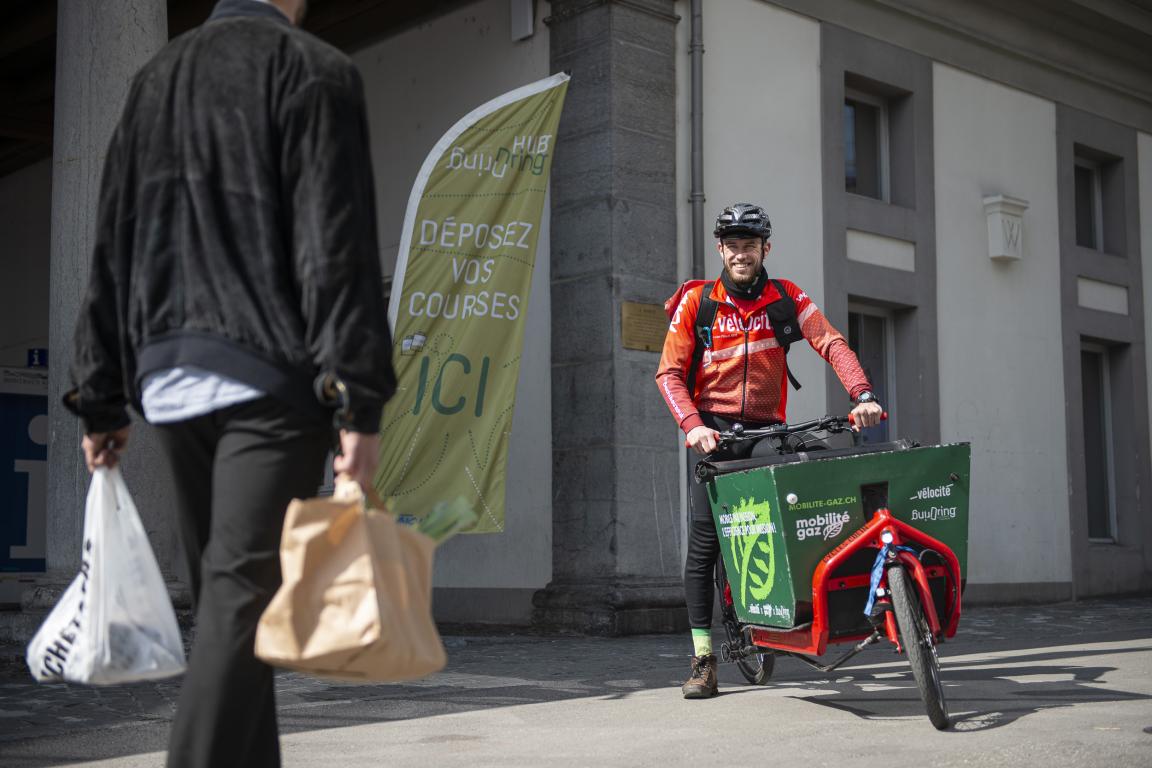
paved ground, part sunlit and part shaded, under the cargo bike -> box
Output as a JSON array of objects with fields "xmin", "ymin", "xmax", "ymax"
[{"xmin": 0, "ymin": 598, "xmax": 1152, "ymax": 768}]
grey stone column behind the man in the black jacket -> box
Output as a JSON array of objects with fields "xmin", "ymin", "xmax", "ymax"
[{"xmin": 40, "ymin": 0, "xmax": 176, "ymax": 608}]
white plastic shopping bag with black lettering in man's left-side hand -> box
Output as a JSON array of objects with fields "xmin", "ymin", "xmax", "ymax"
[{"xmin": 25, "ymin": 467, "xmax": 184, "ymax": 685}]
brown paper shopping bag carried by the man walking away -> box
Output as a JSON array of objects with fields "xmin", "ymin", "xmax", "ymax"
[{"xmin": 256, "ymin": 478, "xmax": 447, "ymax": 680}]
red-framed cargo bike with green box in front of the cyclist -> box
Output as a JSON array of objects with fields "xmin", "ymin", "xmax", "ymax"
[{"xmin": 696, "ymin": 417, "xmax": 970, "ymax": 730}]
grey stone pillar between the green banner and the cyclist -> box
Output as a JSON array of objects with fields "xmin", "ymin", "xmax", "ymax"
[{"xmin": 533, "ymin": 0, "xmax": 688, "ymax": 634}]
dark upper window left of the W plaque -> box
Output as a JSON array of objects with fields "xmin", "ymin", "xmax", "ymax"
[{"xmin": 844, "ymin": 89, "xmax": 889, "ymax": 201}]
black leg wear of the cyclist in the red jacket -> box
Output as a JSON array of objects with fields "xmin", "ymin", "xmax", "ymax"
[{"xmin": 684, "ymin": 413, "xmax": 775, "ymax": 629}]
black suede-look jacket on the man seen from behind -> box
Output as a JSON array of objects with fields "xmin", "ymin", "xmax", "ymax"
[{"xmin": 65, "ymin": 0, "xmax": 395, "ymax": 432}]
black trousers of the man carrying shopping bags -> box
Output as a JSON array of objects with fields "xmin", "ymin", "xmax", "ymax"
[{"xmin": 156, "ymin": 397, "xmax": 332, "ymax": 768}]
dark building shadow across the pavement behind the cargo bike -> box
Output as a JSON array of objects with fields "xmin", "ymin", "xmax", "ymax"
[{"xmin": 0, "ymin": 598, "xmax": 1152, "ymax": 768}]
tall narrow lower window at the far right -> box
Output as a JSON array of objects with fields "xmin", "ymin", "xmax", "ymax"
[{"xmin": 1081, "ymin": 344, "xmax": 1116, "ymax": 541}]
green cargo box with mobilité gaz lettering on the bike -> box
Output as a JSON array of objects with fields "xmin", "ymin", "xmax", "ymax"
[{"xmin": 708, "ymin": 443, "xmax": 970, "ymax": 634}]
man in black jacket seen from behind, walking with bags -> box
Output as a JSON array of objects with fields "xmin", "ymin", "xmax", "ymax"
[{"xmin": 65, "ymin": 0, "xmax": 395, "ymax": 768}]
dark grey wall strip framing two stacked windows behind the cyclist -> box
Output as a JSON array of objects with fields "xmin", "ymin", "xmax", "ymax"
[{"xmin": 820, "ymin": 33, "xmax": 940, "ymax": 443}]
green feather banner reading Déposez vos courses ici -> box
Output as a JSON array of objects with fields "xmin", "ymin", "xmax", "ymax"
[{"xmin": 376, "ymin": 74, "xmax": 568, "ymax": 533}]
